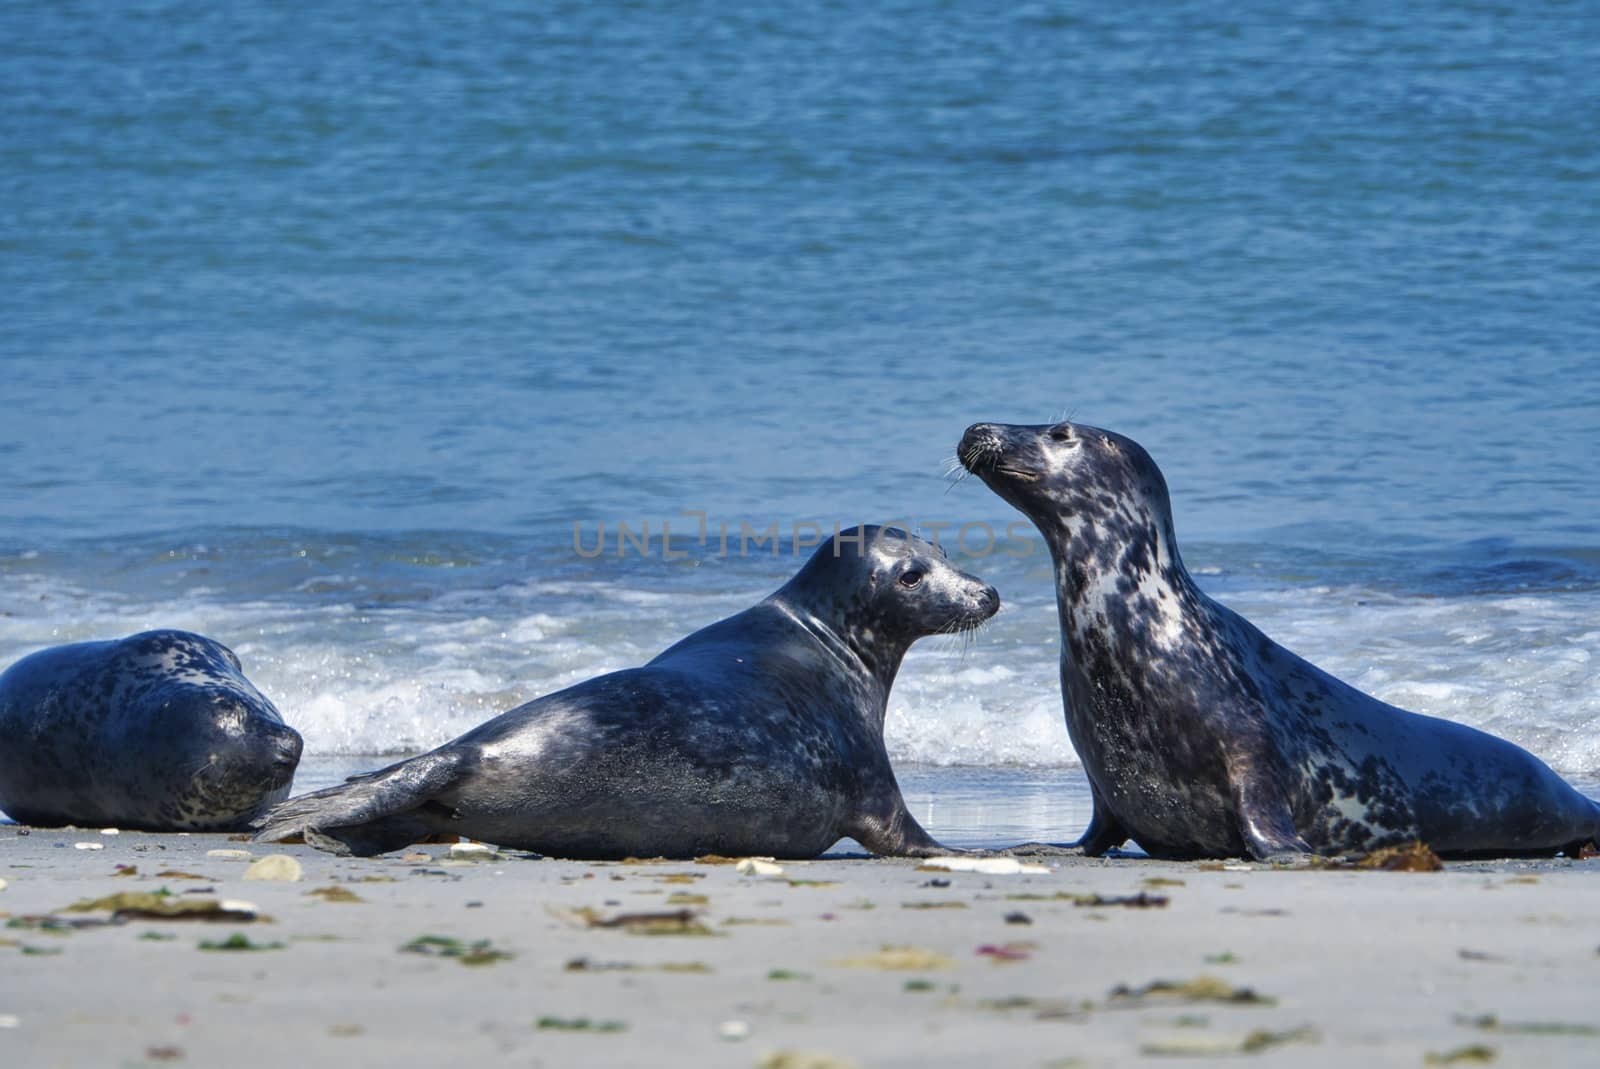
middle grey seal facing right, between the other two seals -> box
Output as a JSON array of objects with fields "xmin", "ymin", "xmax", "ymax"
[{"xmin": 258, "ymin": 526, "xmax": 998, "ymax": 858}]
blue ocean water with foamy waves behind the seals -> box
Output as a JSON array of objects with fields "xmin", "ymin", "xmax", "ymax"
[{"xmin": 0, "ymin": 0, "xmax": 1600, "ymax": 843}]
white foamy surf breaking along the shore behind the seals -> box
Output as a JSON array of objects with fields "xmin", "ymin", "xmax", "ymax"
[{"xmin": 0, "ymin": 570, "xmax": 1600, "ymax": 776}]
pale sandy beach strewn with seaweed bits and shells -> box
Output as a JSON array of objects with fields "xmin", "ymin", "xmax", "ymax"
[{"xmin": 0, "ymin": 827, "xmax": 1600, "ymax": 1069}]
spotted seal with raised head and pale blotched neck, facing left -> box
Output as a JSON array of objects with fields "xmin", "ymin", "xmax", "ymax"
[{"xmin": 958, "ymin": 422, "xmax": 1600, "ymax": 858}]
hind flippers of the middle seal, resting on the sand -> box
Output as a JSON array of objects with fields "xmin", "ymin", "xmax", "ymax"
[{"xmin": 256, "ymin": 747, "xmax": 474, "ymax": 858}]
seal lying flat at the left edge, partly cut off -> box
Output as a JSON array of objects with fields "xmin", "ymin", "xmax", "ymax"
[{"xmin": 0, "ymin": 631, "xmax": 301, "ymax": 831}]
